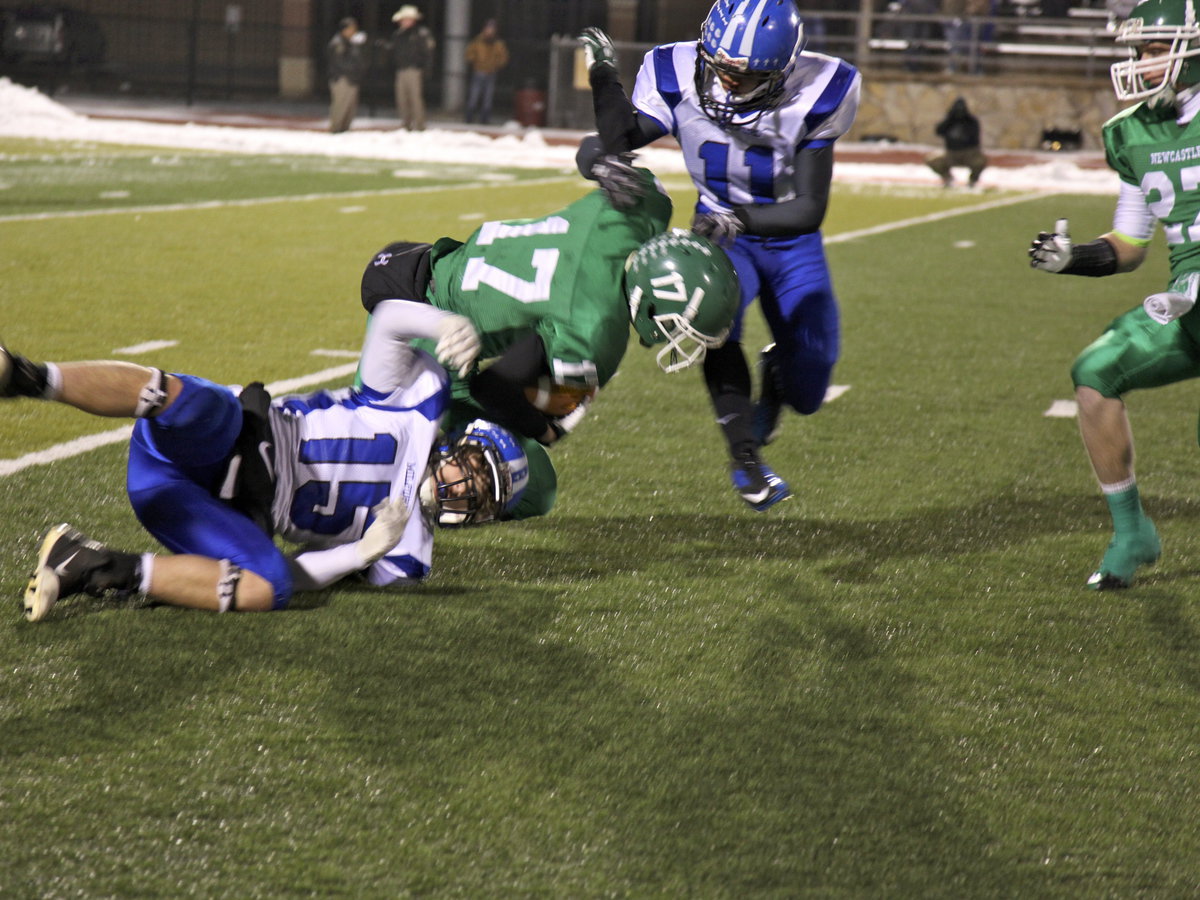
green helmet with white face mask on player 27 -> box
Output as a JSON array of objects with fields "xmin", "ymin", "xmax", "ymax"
[{"xmin": 1110, "ymin": 0, "xmax": 1200, "ymax": 108}]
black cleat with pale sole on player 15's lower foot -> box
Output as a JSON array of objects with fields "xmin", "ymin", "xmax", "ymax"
[{"xmin": 25, "ymin": 523, "xmax": 125, "ymax": 622}]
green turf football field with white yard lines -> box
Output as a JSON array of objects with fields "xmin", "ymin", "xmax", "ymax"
[{"xmin": 0, "ymin": 140, "xmax": 1200, "ymax": 899}]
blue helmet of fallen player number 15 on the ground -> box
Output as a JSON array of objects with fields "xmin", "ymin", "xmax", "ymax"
[{"xmin": 421, "ymin": 419, "xmax": 529, "ymax": 528}]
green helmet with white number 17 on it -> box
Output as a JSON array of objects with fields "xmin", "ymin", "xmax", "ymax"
[{"xmin": 624, "ymin": 228, "xmax": 740, "ymax": 372}]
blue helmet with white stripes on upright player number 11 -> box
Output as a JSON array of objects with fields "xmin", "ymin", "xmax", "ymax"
[{"xmin": 696, "ymin": 0, "xmax": 804, "ymax": 127}]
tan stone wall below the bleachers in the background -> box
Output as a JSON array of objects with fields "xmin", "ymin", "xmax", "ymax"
[{"xmin": 847, "ymin": 74, "xmax": 1121, "ymax": 150}]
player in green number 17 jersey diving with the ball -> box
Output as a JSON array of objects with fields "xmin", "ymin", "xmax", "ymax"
[{"xmin": 362, "ymin": 167, "xmax": 738, "ymax": 518}]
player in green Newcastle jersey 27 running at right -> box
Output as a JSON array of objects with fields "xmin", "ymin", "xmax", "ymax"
[{"xmin": 1030, "ymin": 0, "xmax": 1200, "ymax": 590}]
